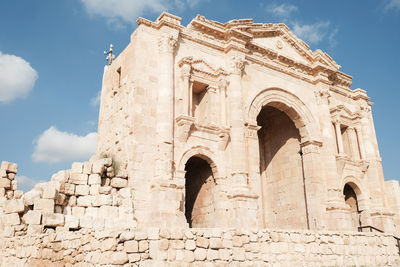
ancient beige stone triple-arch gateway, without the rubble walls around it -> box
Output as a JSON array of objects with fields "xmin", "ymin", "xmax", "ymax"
[{"xmin": 93, "ymin": 13, "xmax": 399, "ymax": 234}]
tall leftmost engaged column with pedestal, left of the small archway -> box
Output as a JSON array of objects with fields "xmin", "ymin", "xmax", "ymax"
[{"xmin": 149, "ymin": 35, "xmax": 187, "ymax": 228}]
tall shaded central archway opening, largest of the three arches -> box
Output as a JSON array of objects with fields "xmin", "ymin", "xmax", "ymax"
[{"xmin": 257, "ymin": 105, "xmax": 308, "ymax": 229}]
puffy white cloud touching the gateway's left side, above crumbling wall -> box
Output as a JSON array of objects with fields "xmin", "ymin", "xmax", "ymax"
[{"xmin": 32, "ymin": 126, "xmax": 97, "ymax": 163}]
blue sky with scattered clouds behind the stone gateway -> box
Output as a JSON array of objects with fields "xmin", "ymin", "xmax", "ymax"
[{"xmin": 0, "ymin": 0, "xmax": 400, "ymax": 193}]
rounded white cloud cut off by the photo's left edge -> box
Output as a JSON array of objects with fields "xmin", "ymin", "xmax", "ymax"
[{"xmin": 0, "ymin": 52, "xmax": 38, "ymax": 103}]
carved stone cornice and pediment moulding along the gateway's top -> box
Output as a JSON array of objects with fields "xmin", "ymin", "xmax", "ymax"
[{"xmin": 138, "ymin": 13, "xmax": 352, "ymax": 90}]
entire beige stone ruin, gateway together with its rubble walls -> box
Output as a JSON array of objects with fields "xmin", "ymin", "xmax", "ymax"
[{"xmin": 0, "ymin": 13, "xmax": 400, "ymax": 266}]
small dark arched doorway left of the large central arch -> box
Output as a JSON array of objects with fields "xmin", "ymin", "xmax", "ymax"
[{"xmin": 185, "ymin": 156, "xmax": 215, "ymax": 228}]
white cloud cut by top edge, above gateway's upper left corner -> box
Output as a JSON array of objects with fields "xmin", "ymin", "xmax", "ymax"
[{"xmin": 81, "ymin": 0, "xmax": 204, "ymax": 28}]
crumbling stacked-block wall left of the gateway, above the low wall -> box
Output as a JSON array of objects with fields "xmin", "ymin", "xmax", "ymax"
[{"xmin": 0, "ymin": 158, "xmax": 137, "ymax": 237}]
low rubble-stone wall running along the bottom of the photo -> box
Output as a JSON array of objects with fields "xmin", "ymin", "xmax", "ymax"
[{"xmin": 0, "ymin": 228, "xmax": 400, "ymax": 267}]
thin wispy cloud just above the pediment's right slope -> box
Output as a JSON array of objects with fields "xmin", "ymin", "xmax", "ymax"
[{"xmin": 292, "ymin": 21, "xmax": 337, "ymax": 44}]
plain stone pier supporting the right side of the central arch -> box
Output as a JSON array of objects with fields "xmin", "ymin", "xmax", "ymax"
[{"xmin": 301, "ymin": 141, "xmax": 326, "ymax": 230}]
